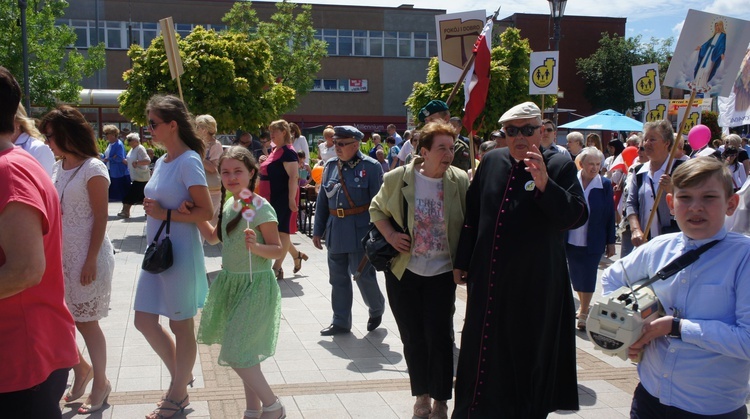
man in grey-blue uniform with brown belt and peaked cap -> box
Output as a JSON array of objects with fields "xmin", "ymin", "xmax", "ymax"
[{"xmin": 313, "ymin": 125, "xmax": 385, "ymax": 336}]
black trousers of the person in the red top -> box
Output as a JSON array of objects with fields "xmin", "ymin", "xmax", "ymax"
[{"xmin": 0, "ymin": 368, "xmax": 70, "ymax": 419}]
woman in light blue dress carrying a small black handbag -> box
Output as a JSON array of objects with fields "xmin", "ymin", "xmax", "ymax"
[{"xmin": 135, "ymin": 95, "xmax": 213, "ymax": 419}]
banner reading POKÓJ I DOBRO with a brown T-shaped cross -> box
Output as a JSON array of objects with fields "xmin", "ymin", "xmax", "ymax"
[{"xmin": 435, "ymin": 10, "xmax": 487, "ymax": 83}]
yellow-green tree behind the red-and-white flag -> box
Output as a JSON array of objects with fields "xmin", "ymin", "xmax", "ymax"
[{"xmin": 406, "ymin": 28, "xmax": 555, "ymax": 138}]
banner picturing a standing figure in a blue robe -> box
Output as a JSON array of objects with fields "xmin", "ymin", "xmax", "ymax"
[{"xmin": 664, "ymin": 10, "xmax": 750, "ymax": 97}]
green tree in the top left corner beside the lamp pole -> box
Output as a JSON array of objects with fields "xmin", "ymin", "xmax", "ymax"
[{"xmin": 0, "ymin": 0, "xmax": 104, "ymax": 108}]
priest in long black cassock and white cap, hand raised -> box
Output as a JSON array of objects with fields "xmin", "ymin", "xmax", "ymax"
[{"xmin": 452, "ymin": 102, "xmax": 588, "ymax": 419}]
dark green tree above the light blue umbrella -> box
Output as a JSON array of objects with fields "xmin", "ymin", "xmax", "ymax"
[{"xmin": 576, "ymin": 32, "xmax": 673, "ymax": 113}]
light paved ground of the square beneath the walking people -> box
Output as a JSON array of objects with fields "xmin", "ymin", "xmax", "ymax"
[{"xmin": 63, "ymin": 203, "xmax": 638, "ymax": 419}]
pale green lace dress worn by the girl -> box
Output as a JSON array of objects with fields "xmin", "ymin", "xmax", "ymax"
[{"xmin": 198, "ymin": 199, "xmax": 281, "ymax": 368}]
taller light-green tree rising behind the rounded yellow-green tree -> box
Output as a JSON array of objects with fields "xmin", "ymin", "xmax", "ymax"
[{"xmin": 222, "ymin": 0, "xmax": 327, "ymax": 104}]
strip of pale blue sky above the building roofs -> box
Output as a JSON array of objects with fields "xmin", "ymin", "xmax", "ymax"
[{"xmin": 301, "ymin": 0, "xmax": 750, "ymax": 47}]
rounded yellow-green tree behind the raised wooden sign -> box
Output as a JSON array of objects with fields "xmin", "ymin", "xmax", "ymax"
[{"xmin": 119, "ymin": 26, "xmax": 294, "ymax": 131}]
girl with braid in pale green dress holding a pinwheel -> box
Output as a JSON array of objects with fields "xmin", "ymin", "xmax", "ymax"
[{"xmin": 187, "ymin": 147, "xmax": 286, "ymax": 419}]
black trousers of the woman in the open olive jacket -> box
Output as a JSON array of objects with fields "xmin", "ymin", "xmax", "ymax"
[{"xmin": 385, "ymin": 270, "xmax": 456, "ymax": 400}]
